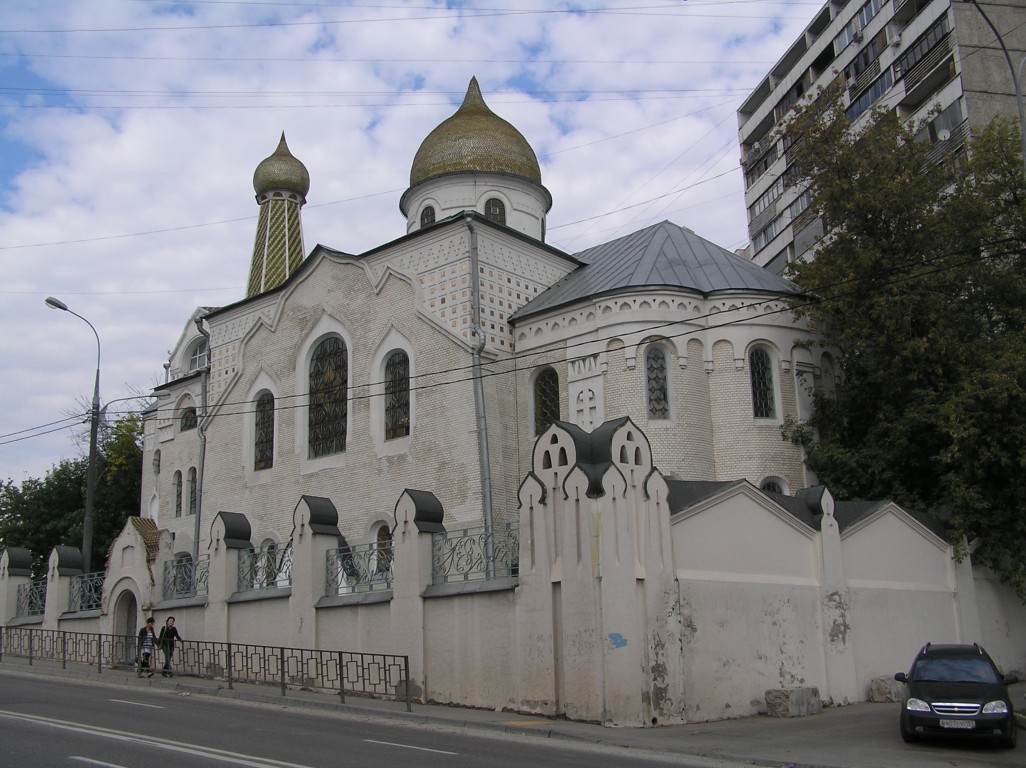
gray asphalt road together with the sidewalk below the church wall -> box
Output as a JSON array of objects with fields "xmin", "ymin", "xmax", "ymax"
[{"xmin": 0, "ymin": 658, "xmax": 1026, "ymax": 768}]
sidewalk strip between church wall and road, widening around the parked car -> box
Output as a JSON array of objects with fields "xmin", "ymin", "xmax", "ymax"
[{"xmin": 0, "ymin": 656, "xmax": 1026, "ymax": 768}]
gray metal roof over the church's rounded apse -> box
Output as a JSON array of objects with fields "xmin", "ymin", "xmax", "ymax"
[{"xmin": 512, "ymin": 221, "xmax": 799, "ymax": 322}]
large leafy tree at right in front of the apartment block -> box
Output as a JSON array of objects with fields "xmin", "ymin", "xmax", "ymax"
[{"xmin": 785, "ymin": 88, "xmax": 1026, "ymax": 602}]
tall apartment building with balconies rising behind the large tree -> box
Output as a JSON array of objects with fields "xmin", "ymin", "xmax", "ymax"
[{"xmin": 738, "ymin": 0, "xmax": 1026, "ymax": 273}]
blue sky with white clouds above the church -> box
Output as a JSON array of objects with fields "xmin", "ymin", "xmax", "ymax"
[{"xmin": 0, "ymin": 0, "xmax": 822, "ymax": 485}]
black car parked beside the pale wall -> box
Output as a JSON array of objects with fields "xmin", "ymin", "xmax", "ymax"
[{"xmin": 895, "ymin": 643, "xmax": 1019, "ymax": 747}]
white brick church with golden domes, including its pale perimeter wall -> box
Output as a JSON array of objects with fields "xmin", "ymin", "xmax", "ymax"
[{"xmin": 6, "ymin": 80, "xmax": 1026, "ymax": 726}]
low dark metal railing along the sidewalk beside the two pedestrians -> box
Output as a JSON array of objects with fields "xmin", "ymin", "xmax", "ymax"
[{"xmin": 0, "ymin": 626, "xmax": 412, "ymax": 712}]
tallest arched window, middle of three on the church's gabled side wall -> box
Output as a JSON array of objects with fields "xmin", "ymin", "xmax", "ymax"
[{"xmin": 308, "ymin": 336, "xmax": 349, "ymax": 458}]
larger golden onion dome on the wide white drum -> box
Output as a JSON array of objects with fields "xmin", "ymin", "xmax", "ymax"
[{"xmin": 409, "ymin": 77, "xmax": 542, "ymax": 187}]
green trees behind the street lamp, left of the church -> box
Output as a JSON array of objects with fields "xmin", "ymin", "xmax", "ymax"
[{"xmin": 0, "ymin": 415, "xmax": 143, "ymax": 578}]
